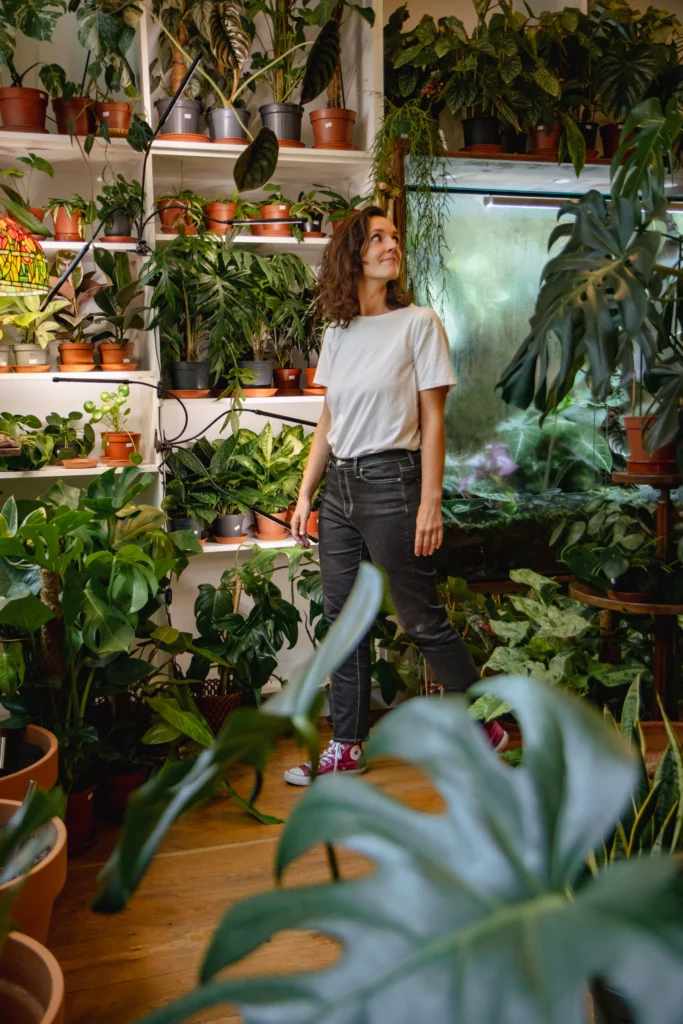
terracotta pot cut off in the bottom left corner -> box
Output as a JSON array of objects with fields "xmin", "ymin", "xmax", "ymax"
[{"xmin": 0, "ymin": 932, "xmax": 65, "ymax": 1024}]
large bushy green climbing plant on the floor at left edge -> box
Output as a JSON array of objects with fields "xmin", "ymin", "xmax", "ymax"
[{"xmin": 0, "ymin": 475, "xmax": 201, "ymax": 788}]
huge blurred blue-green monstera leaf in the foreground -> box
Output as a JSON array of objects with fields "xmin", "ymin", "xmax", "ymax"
[{"xmin": 135, "ymin": 678, "xmax": 683, "ymax": 1024}]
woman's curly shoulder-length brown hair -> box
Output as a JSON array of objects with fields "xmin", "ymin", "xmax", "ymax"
[{"xmin": 317, "ymin": 206, "xmax": 411, "ymax": 327}]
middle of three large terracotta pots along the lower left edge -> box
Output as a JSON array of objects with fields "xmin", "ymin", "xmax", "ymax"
[{"xmin": 0, "ymin": 800, "xmax": 67, "ymax": 942}]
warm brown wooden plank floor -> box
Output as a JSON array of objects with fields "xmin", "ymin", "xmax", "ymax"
[{"xmin": 48, "ymin": 740, "xmax": 441, "ymax": 1024}]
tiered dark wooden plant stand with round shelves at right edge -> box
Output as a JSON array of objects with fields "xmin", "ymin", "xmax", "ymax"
[{"xmin": 569, "ymin": 473, "xmax": 683, "ymax": 719}]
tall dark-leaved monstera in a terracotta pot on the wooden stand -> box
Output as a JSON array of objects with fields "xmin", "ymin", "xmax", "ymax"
[{"xmin": 498, "ymin": 98, "xmax": 683, "ymax": 451}]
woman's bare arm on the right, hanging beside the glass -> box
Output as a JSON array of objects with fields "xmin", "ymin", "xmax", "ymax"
[{"xmin": 415, "ymin": 387, "xmax": 449, "ymax": 555}]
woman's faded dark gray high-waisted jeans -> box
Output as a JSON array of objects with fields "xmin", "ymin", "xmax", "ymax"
[{"xmin": 318, "ymin": 449, "xmax": 479, "ymax": 742}]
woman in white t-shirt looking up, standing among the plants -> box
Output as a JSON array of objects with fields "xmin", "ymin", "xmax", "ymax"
[{"xmin": 285, "ymin": 207, "xmax": 507, "ymax": 785}]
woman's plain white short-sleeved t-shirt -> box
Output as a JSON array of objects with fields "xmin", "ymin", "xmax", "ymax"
[{"xmin": 315, "ymin": 304, "xmax": 456, "ymax": 459}]
